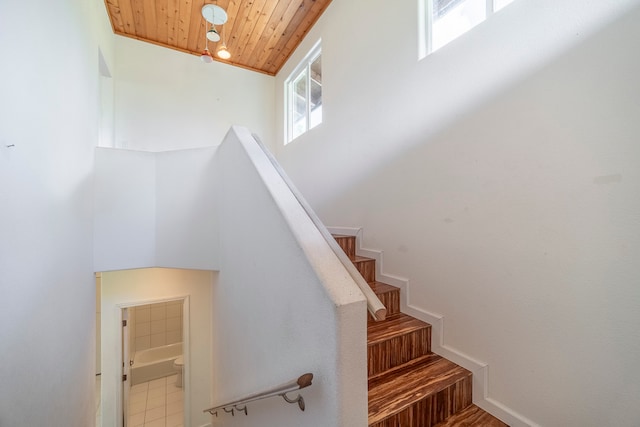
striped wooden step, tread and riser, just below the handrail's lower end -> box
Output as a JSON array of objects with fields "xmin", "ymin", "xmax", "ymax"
[{"xmin": 367, "ymin": 313, "xmax": 431, "ymax": 376}]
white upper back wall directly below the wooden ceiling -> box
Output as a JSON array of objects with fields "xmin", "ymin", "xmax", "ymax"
[{"xmin": 115, "ymin": 36, "xmax": 274, "ymax": 151}]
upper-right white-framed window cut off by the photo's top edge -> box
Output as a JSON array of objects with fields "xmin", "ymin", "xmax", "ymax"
[{"xmin": 421, "ymin": 0, "xmax": 514, "ymax": 56}]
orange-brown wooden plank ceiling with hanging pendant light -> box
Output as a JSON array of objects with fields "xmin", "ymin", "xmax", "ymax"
[{"xmin": 105, "ymin": 0, "xmax": 331, "ymax": 75}]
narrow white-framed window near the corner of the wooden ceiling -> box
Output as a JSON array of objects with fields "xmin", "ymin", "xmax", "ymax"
[{"xmin": 285, "ymin": 42, "xmax": 322, "ymax": 144}]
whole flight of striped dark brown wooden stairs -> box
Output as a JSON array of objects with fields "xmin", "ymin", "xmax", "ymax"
[{"xmin": 334, "ymin": 235, "xmax": 508, "ymax": 427}]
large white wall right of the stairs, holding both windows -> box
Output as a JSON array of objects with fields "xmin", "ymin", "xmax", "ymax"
[{"xmin": 276, "ymin": 0, "xmax": 640, "ymax": 426}]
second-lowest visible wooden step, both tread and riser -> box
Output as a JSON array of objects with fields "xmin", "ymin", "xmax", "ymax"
[{"xmin": 369, "ymin": 354, "xmax": 472, "ymax": 427}]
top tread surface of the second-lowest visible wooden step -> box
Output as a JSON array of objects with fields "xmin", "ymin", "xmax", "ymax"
[{"xmin": 369, "ymin": 353, "xmax": 472, "ymax": 425}]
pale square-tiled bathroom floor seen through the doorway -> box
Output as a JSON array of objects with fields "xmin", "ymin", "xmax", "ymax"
[{"xmin": 127, "ymin": 375, "xmax": 184, "ymax": 427}]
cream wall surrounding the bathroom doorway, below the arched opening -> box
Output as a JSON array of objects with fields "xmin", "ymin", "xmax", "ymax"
[{"xmin": 99, "ymin": 268, "xmax": 211, "ymax": 427}]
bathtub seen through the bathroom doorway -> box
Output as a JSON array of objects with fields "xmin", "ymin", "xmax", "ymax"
[{"xmin": 130, "ymin": 342, "xmax": 182, "ymax": 385}]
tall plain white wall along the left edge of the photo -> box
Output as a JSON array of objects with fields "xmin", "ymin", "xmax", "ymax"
[{"xmin": 0, "ymin": 0, "xmax": 109, "ymax": 427}]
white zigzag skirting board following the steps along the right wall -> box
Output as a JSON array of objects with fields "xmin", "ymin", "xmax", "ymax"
[{"xmin": 327, "ymin": 226, "xmax": 539, "ymax": 427}]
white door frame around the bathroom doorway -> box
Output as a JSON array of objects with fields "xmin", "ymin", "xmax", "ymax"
[{"xmin": 115, "ymin": 295, "xmax": 191, "ymax": 427}]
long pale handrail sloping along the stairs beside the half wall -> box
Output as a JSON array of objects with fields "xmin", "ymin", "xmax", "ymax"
[{"xmin": 253, "ymin": 134, "xmax": 387, "ymax": 321}]
